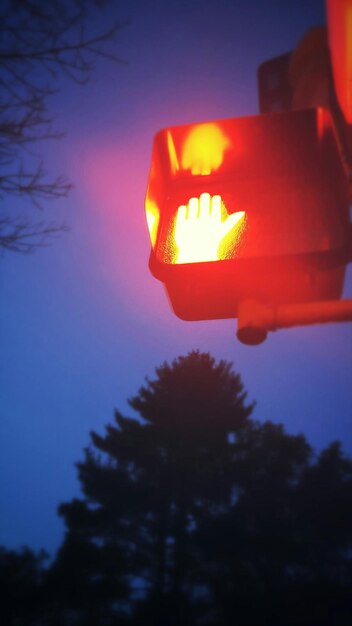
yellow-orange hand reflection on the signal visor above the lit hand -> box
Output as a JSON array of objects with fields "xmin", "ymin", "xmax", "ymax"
[{"xmin": 182, "ymin": 124, "xmax": 231, "ymax": 176}]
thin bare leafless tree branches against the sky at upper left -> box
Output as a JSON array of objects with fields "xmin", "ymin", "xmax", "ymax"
[{"xmin": 0, "ymin": 0, "xmax": 122, "ymax": 252}]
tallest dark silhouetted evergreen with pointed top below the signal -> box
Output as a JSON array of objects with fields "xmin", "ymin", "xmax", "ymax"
[{"xmin": 55, "ymin": 352, "xmax": 252, "ymax": 625}]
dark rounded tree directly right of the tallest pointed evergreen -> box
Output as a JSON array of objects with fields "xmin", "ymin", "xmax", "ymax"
[{"xmin": 198, "ymin": 422, "xmax": 311, "ymax": 624}]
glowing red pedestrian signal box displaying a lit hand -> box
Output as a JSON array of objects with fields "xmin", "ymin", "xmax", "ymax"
[{"xmin": 146, "ymin": 108, "xmax": 350, "ymax": 320}]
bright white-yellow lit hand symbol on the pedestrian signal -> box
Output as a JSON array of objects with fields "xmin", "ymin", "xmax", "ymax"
[{"xmin": 173, "ymin": 193, "xmax": 245, "ymax": 264}]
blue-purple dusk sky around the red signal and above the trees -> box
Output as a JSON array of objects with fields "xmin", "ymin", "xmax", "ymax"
[{"xmin": 0, "ymin": 0, "xmax": 352, "ymax": 555}]
